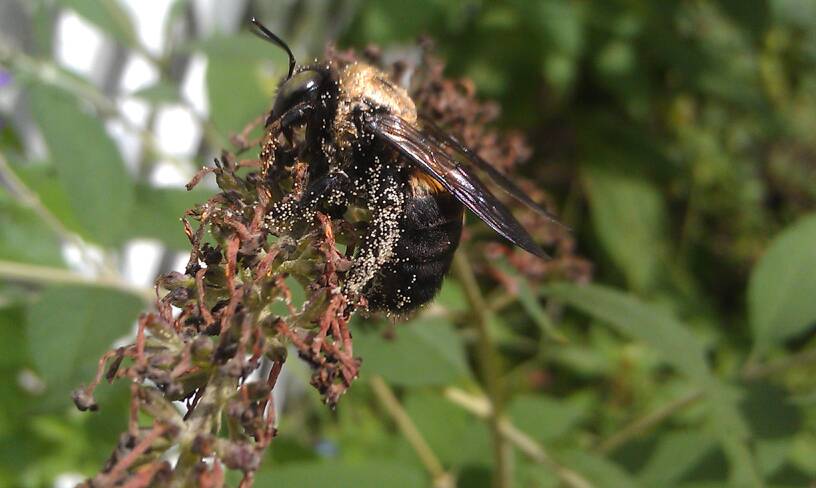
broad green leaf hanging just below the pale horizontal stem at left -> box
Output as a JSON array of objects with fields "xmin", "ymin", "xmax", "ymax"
[{"xmin": 28, "ymin": 286, "xmax": 142, "ymax": 404}]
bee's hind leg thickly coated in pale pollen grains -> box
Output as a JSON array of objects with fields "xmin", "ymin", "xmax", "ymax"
[{"xmin": 344, "ymin": 168, "xmax": 405, "ymax": 303}]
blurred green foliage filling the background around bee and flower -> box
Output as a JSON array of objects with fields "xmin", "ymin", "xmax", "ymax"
[{"xmin": 0, "ymin": 0, "xmax": 816, "ymax": 487}]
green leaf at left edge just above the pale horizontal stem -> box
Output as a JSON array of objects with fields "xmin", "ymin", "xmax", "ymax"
[{"xmin": 0, "ymin": 189, "xmax": 63, "ymax": 266}]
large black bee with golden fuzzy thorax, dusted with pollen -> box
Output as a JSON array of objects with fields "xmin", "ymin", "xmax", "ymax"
[{"xmin": 252, "ymin": 18, "xmax": 553, "ymax": 315}]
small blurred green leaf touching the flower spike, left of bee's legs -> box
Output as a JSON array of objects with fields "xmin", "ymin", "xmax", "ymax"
[{"xmin": 128, "ymin": 184, "xmax": 213, "ymax": 251}]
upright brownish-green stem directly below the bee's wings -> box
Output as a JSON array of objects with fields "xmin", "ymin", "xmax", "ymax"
[{"xmin": 453, "ymin": 252, "xmax": 513, "ymax": 488}]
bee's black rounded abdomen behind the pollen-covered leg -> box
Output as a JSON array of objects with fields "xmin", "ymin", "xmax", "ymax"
[{"xmin": 366, "ymin": 191, "xmax": 463, "ymax": 314}]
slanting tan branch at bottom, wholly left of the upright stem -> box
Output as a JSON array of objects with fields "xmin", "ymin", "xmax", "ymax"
[{"xmin": 371, "ymin": 375, "xmax": 455, "ymax": 488}]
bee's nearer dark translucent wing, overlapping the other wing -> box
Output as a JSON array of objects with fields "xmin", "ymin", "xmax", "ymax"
[{"xmin": 367, "ymin": 114, "xmax": 548, "ymax": 259}]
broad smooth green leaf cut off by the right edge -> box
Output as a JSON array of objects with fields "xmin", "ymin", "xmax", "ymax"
[{"xmin": 748, "ymin": 214, "xmax": 816, "ymax": 352}]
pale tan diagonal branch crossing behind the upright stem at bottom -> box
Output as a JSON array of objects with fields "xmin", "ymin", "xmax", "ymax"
[{"xmin": 444, "ymin": 388, "xmax": 594, "ymax": 488}]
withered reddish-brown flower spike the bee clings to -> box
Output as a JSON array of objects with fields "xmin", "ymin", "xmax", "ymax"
[{"xmin": 74, "ymin": 43, "xmax": 587, "ymax": 487}]
